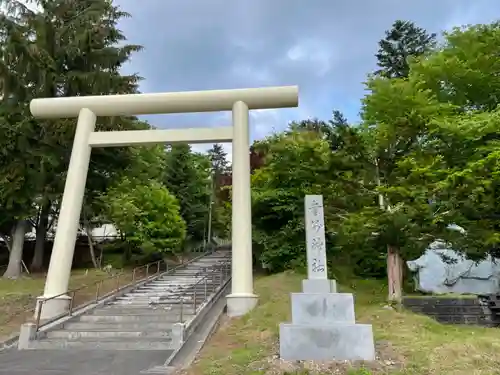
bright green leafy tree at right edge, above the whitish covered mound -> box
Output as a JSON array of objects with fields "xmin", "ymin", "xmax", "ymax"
[{"xmin": 404, "ymin": 22, "xmax": 500, "ymax": 259}]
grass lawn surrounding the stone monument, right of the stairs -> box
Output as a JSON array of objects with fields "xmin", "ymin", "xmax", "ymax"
[{"xmin": 186, "ymin": 273, "xmax": 500, "ymax": 375}]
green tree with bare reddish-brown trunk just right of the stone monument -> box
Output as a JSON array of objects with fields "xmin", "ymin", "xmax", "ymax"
[{"xmin": 346, "ymin": 73, "xmax": 451, "ymax": 302}]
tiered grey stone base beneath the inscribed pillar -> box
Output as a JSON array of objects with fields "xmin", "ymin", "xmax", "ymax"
[{"xmin": 280, "ymin": 280, "xmax": 375, "ymax": 361}]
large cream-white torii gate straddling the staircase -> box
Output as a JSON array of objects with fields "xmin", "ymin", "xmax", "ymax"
[{"xmin": 30, "ymin": 86, "xmax": 299, "ymax": 319}]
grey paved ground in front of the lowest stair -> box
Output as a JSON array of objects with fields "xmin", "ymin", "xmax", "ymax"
[{"xmin": 0, "ymin": 349, "xmax": 172, "ymax": 375}]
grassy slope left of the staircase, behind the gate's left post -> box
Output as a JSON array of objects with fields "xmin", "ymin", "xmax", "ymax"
[{"xmin": 0, "ymin": 269, "xmax": 138, "ymax": 341}]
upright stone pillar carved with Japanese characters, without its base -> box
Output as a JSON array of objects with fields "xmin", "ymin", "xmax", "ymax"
[{"xmin": 305, "ymin": 195, "xmax": 327, "ymax": 279}]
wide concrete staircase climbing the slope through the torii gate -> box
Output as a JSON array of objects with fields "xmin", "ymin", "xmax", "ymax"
[{"xmin": 26, "ymin": 250, "xmax": 230, "ymax": 350}]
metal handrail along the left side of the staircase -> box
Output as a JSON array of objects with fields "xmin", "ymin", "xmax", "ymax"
[{"xmin": 35, "ymin": 250, "xmax": 213, "ymax": 332}]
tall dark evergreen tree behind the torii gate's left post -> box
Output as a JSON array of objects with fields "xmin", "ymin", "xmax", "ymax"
[{"xmin": 0, "ymin": 0, "xmax": 145, "ymax": 270}]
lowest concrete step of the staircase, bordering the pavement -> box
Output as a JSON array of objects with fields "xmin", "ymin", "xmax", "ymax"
[{"xmin": 30, "ymin": 338, "xmax": 175, "ymax": 350}]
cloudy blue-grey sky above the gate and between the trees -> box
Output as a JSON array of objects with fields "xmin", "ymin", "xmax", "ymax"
[{"xmin": 115, "ymin": 0, "xmax": 500, "ymax": 159}]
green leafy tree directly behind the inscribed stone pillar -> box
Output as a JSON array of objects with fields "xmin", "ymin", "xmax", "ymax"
[{"xmin": 252, "ymin": 130, "xmax": 368, "ymax": 271}]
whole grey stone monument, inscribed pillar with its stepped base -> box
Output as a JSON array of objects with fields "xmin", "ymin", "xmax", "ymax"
[{"xmin": 280, "ymin": 195, "xmax": 375, "ymax": 361}]
